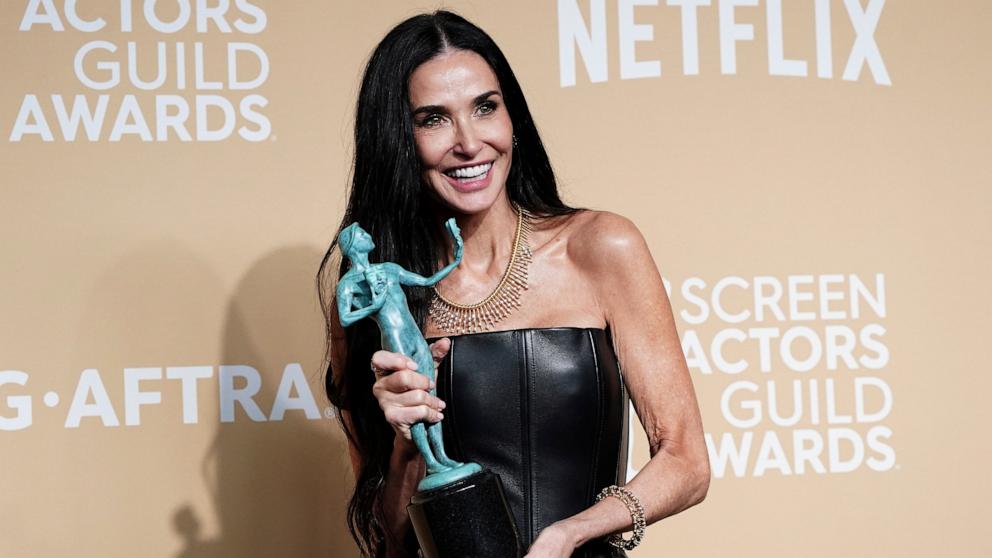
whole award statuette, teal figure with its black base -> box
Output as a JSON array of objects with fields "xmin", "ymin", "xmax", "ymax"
[{"xmin": 337, "ymin": 219, "xmax": 523, "ymax": 558}]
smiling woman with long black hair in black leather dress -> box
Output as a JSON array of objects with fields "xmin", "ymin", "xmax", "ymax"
[{"xmin": 320, "ymin": 11, "xmax": 709, "ymax": 557}]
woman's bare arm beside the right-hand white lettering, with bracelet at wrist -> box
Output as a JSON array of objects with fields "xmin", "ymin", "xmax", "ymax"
[{"xmin": 544, "ymin": 213, "xmax": 710, "ymax": 545}]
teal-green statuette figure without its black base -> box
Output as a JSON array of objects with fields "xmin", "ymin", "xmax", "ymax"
[{"xmin": 337, "ymin": 219, "xmax": 482, "ymax": 491}]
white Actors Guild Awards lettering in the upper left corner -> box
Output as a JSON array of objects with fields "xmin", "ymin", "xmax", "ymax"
[{"xmin": 8, "ymin": 0, "xmax": 272, "ymax": 142}]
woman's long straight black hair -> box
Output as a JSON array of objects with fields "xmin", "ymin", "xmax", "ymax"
[{"xmin": 317, "ymin": 11, "xmax": 576, "ymax": 556}]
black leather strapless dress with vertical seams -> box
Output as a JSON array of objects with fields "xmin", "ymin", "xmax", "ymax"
[{"xmin": 430, "ymin": 328, "xmax": 629, "ymax": 558}]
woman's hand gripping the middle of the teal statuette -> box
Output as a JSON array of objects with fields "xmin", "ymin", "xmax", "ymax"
[{"xmin": 372, "ymin": 338, "xmax": 451, "ymax": 441}]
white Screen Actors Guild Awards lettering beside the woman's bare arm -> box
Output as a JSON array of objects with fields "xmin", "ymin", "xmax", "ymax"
[{"xmin": 666, "ymin": 273, "xmax": 896, "ymax": 478}]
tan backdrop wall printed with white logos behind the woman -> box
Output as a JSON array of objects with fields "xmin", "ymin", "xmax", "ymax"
[{"xmin": 0, "ymin": 0, "xmax": 992, "ymax": 558}]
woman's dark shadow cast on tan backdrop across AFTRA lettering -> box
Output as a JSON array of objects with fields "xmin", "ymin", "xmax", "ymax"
[{"xmin": 172, "ymin": 246, "xmax": 359, "ymax": 558}]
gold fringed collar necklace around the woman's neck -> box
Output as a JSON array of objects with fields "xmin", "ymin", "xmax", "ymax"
[{"xmin": 428, "ymin": 204, "xmax": 532, "ymax": 334}]
